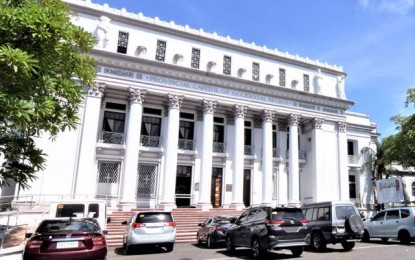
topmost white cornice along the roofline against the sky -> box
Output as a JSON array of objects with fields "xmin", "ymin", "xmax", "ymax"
[{"xmin": 64, "ymin": 0, "xmax": 346, "ymax": 75}]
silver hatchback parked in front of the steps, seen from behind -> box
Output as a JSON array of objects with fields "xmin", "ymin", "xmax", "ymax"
[{"xmin": 121, "ymin": 211, "xmax": 176, "ymax": 254}]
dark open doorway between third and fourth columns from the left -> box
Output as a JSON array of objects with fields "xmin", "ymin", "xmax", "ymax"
[{"xmin": 176, "ymin": 165, "xmax": 192, "ymax": 207}]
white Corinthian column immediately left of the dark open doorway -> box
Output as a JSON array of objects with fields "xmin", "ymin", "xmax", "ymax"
[{"xmin": 160, "ymin": 94, "xmax": 184, "ymax": 211}]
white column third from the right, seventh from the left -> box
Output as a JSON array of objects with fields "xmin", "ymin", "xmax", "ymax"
[{"xmin": 288, "ymin": 114, "xmax": 300, "ymax": 205}]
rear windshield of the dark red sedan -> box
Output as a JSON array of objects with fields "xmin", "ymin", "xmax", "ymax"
[{"xmin": 36, "ymin": 219, "xmax": 99, "ymax": 233}]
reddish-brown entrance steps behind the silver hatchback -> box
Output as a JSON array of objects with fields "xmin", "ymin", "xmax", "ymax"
[{"xmin": 107, "ymin": 208, "xmax": 242, "ymax": 247}]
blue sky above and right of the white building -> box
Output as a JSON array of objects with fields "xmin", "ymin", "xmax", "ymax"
[{"xmin": 92, "ymin": 0, "xmax": 415, "ymax": 139}]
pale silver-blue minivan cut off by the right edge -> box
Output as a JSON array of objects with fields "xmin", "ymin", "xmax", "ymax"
[{"xmin": 362, "ymin": 207, "xmax": 415, "ymax": 244}]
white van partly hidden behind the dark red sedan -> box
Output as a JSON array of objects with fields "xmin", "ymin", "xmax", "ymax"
[{"xmin": 49, "ymin": 200, "xmax": 111, "ymax": 230}]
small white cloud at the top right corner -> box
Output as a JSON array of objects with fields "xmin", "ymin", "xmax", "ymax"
[{"xmin": 359, "ymin": 0, "xmax": 415, "ymax": 15}]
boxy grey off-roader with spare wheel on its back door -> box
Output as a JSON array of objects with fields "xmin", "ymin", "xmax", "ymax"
[{"xmin": 302, "ymin": 201, "xmax": 364, "ymax": 251}]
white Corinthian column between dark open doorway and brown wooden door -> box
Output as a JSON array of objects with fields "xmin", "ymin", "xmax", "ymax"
[{"xmin": 197, "ymin": 99, "xmax": 217, "ymax": 210}]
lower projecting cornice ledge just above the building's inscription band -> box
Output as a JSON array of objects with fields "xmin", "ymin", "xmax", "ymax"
[{"xmin": 89, "ymin": 50, "xmax": 354, "ymax": 110}]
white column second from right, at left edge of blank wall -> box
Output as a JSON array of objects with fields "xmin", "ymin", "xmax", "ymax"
[{"xmin": 310, "ymin": 118, "xmax": 327, "ymax": 202}]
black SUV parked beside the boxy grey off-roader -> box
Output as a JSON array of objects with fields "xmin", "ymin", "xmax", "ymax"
[{"xmin": 226, "ymin": 207, "xmax": 310, "ymax": 258}]
